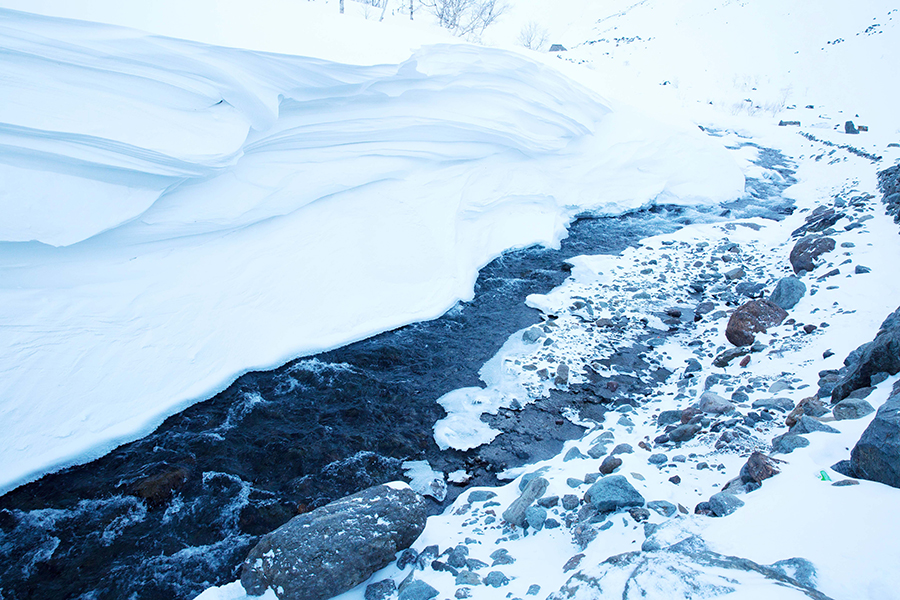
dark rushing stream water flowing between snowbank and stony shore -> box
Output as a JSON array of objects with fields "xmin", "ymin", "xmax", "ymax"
[{"xmin": 0, "ymin": 149, "xmax": 792, "ymax": 600}]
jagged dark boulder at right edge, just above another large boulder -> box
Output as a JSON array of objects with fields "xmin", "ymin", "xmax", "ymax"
[{"xmin": 831, "ymin": 308, "xmax": 900, "ymax": 403}]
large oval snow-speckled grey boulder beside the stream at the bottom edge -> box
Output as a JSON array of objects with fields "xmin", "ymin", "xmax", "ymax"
[{"xmin": 241, "ymin": 485, "xmax": 427, "ymax": 600}]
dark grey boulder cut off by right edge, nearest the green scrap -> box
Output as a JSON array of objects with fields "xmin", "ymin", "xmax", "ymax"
[{"xmin": 850, "ymin": 384, "xmax": 900, "ymax": 488}]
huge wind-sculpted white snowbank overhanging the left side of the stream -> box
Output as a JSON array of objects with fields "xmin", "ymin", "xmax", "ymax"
[{"xmin": 0, "ymin": 10, "xmax": 743, "ymax": 490}]
